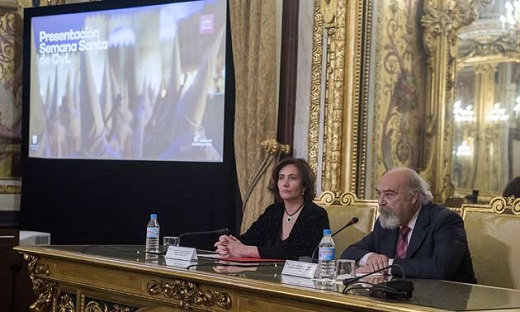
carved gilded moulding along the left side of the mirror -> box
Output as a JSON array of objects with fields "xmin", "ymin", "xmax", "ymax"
[{"xmin": 421, "ymin": 0, "xmax": 488, "ymax": 202}]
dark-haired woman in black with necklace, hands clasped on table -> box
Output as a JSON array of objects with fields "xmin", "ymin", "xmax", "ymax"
[{"xmin": 215, "ymin": 158, "xmax": 329, "ymax": 260}]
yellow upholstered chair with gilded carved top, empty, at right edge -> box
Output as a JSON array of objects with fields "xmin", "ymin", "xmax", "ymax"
[{"xmin": 462, "ymin": 197, "xmax": 520, "ymax": 289}]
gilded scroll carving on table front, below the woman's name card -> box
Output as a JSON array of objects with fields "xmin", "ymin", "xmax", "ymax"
[{"xmin": 146, "ymin": 279, "xmax": 232, "ymax": 310}]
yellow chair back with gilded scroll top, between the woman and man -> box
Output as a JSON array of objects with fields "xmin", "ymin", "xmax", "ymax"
[{"xmin": 315, "ymin": 191, "xmax": 378, "ymax": 258}]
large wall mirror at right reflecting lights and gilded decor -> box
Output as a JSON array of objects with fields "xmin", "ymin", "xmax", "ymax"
[{"xmin": 451, "ymin": 0, "xmax": 520, "ymax": 200}]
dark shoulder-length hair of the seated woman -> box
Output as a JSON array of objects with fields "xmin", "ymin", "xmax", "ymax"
[{"xmin": 267, "ymin": 157, "xmax": 316, "ymax": 201}]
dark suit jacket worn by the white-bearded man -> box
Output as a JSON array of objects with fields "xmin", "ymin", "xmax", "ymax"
[{"xmin": 341, "ymin": 203, "xmax": 477, "ymax": 283}]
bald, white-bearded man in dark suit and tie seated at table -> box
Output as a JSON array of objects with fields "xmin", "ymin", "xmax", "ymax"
[{"xmin": 341, "ymin": 168, "xmax": 477, "ymax": 283}]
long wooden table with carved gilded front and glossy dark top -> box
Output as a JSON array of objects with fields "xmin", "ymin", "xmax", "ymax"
[{"xmin": 15, "ymin": 245, "xmax": 520, "ymax": 312}]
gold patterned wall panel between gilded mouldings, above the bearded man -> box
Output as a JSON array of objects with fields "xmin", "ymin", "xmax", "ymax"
[{"xmin": 369, "ymin": 0, "xmax": 426, "ymax": 197}]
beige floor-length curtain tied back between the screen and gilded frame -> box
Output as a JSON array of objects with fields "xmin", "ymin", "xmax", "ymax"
[{"xmin": 229, "ymin": 0, "xmax": 278, "ymax": 232}]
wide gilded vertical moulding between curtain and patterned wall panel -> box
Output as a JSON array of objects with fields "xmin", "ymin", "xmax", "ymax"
[{"xmin": 308, "ymin": 0, "xmax": 372, "ymax": 197}]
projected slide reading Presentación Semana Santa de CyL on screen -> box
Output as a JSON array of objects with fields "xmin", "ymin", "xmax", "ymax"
[{"xmin": 28, "ymin": 0, "xmax": 226, "ymax": 162}]
